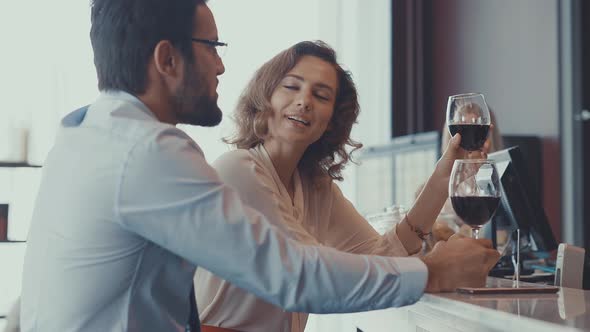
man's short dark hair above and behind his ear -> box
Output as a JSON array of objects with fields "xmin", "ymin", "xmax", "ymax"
[{"xmin": 90, "ymin": 0, "xmax": 206, "ymax": 95}]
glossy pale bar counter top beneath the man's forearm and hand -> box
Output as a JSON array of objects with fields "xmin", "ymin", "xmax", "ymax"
[{"xmin": 314, "ymin": 278, "xmax": 590, "ymax": 332}]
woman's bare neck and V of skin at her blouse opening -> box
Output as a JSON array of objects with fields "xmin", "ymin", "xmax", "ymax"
[{"xmin": 264, "ymin": 140, "xmax": 307, "ymax": 199}]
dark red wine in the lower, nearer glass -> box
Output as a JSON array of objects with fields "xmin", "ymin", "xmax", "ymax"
[{"xmin": 451, "ymin": 196, "xmax": 500, "ymax": 227}]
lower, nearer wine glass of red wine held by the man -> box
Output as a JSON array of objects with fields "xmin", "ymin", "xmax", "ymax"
[{"xmin": 449, "ymin": 159, "xmax": 500, "ymax": 239}]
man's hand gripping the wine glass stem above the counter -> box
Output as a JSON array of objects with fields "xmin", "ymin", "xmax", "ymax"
[{"xmin": 422, "ymin": 235, "xmax": 500, "ymax": 293}]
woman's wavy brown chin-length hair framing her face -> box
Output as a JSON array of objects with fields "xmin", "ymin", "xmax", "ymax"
[{"xmin": 225, "ymin": 41, "xmax": 362, "ymax": 180}]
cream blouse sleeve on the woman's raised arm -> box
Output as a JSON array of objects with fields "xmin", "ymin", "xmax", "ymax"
[{"xmin": 321, "ymin": 181, "xmax": 408, "ymax": 256}]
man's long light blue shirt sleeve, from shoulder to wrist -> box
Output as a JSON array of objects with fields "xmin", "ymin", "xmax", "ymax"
[{"xmin": 114, "ymin": 128, "xmax": 427, "ymax": 313}]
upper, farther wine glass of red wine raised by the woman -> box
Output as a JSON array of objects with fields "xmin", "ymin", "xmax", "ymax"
[{"xmin": 447, "ymin": 93, "xmax": 491, "ymax": 151}]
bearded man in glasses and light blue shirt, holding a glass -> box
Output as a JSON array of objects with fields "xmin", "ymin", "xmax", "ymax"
[{"xmin": 21, "ymin": 0, "xmax": 497, "ymax": 331}]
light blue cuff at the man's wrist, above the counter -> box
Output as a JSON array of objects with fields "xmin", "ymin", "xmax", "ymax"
[{"xmin": 395, "ymin": 257, "xmax": 428, "ymax": 305}]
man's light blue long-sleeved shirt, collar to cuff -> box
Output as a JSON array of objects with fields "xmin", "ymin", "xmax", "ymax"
[{"xmin": 21, "ymin": 92, "xmax": 427, "ymax": 332}]
